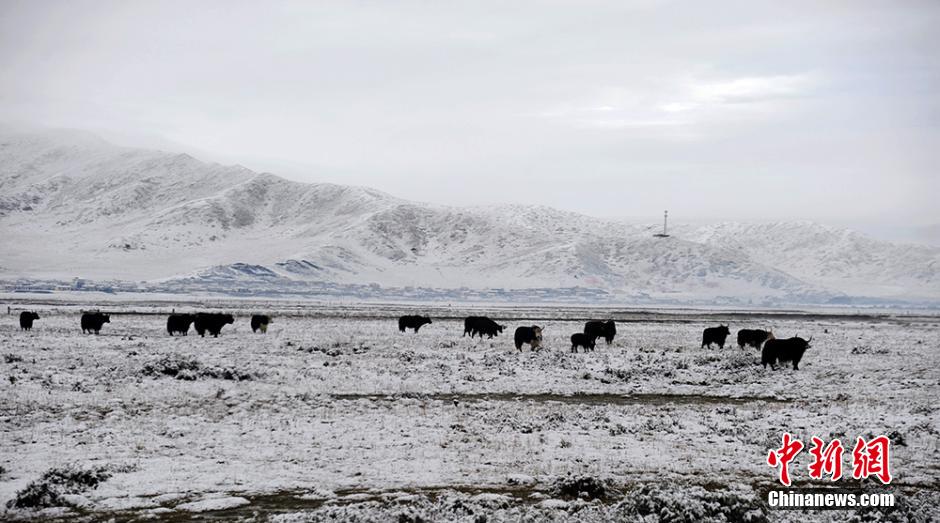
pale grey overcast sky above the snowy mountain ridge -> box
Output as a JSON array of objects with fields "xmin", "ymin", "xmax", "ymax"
[{"xmin": 0, "ymin": 0, "xmax": 940, "ymax": 233}]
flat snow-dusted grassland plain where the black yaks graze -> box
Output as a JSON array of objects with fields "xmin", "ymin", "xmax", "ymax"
[{"xmin": 0, "ymin": 303, "xmax": 940, "ymax": 521}]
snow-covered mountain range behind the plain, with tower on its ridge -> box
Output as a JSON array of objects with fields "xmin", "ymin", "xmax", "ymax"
[{"xmin": 0, "ymin": 129, "xmax": 940, "ymax": 302}]
